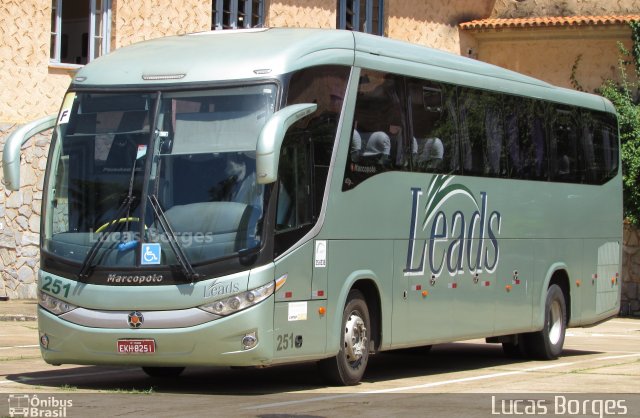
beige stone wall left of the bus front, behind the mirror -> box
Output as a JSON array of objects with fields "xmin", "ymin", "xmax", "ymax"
[{"xmin": 0, "ymin": 125, "xmax": 51, "ymax": 299}]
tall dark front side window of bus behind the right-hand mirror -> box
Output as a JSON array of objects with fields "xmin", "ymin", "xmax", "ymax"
[{"xmin": 275, "ymin": 66, "xmax": 350, "ymax": 254}]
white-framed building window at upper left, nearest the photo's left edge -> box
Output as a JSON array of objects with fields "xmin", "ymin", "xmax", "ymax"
[{"xmin": 50, "ymin": 0, "xmax": 111, "ymax": 64}]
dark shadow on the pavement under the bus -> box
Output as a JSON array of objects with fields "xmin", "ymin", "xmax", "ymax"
[{"xmin": 6, "ymin": 343, "xmax": 598, "ymax": 396}]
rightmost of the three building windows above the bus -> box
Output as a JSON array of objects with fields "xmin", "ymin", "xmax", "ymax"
[{"xmin": 337, "ymin": 0, "xmax": 384, "ymax": 35}]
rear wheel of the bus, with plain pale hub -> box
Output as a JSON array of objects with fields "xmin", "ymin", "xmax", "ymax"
[{"xmin": 524, "ymin": 284, "xmax": 567, "ymax": 360}]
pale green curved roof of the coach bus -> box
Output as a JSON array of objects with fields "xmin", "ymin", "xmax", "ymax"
[{"xmin": 72, "ymin": 28, "xmax": 615, "ymax": 112}]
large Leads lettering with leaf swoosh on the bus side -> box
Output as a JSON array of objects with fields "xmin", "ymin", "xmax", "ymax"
[{"xmin": 403, "ymin": 175, "xmax": 502, "ymax": 277}]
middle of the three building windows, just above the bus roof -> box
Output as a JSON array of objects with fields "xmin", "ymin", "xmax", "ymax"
[{"xmin": 211, "ymin": 0, "xmax": 264, "ymax": 30}]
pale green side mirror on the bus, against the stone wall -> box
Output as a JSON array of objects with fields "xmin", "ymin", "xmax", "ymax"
[{"xmin": 2, "ymin": 115, "xmax": 56, "ymax": 191}]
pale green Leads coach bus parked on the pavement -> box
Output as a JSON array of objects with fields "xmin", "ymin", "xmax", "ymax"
[{"xmin": 5, "ymin": 29, "xmax": 622, "ymax": 385}]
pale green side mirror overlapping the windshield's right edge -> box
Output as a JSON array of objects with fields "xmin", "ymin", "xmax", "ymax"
[{"xmin": 256, "ymin": 103, "xmax": 318, "ymax": 184}]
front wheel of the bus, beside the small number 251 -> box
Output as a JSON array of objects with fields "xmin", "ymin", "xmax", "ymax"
[{"xmin": 319, "ymin": 289, "xmax": 371, "ymax": 385}]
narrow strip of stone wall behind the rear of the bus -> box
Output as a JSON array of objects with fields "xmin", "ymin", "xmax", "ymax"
[{"xmin": 620, "ymin": 225, "xmax": 640, "ymax": 316}]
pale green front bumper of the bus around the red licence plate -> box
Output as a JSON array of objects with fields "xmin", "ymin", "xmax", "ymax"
[{"xmin": 38, "ymin": 296, "xmax": 274, "ymax": 367}]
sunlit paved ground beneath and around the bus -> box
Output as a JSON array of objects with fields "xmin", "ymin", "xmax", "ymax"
[{"xmin": 0, "ymin": 302, "xmax": 640, "ymax": 418}]
